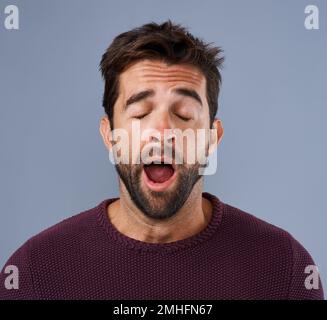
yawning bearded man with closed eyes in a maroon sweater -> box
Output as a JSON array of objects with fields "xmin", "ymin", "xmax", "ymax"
[{"xmin": 0, "ymin": 21, "xmax": 323, "ymax": 299}]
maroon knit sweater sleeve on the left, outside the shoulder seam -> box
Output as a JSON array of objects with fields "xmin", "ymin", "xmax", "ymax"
[{"xmin": 0, "ymin": 241, "xmax": 36, "ymax": 300}]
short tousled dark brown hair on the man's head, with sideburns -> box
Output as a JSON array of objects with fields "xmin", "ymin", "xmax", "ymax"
[{"xmin": 100, "ymin": 20, "xmax": 224, "ymax": 128}]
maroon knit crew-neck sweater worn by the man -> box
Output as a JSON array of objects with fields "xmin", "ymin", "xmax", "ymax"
[{"xmin": 0, "ymin": 193, "xmax": 323, "ymax": 299}]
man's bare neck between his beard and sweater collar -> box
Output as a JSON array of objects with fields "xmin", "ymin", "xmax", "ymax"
[{"xmin": 108, "ymin": 178, "xmax": 212, "ymax": 243}]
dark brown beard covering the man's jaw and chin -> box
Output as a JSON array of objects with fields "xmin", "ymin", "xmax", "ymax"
[{"xmin": 115, "ymin": 163, "xmax": 201, "ymax": 220}]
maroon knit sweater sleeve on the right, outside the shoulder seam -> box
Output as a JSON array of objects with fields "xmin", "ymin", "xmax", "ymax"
[{"xmin": 288, "ymin": 236, "xmax": 324, "ymax": 300}]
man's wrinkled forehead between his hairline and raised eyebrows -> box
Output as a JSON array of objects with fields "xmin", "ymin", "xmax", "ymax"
[{"xmin": 120, "ymin": 60, "xmax": 205, "ymax": 91}]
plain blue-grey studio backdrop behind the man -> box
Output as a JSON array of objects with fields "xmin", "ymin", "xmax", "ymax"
[{"xmin": 0, "ymin": 0, "xmax": 327, "ymax": 291}]
